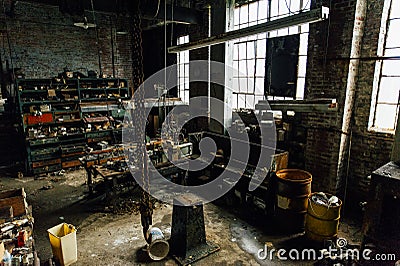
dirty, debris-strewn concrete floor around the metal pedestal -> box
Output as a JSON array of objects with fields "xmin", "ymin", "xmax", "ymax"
[{"xmin": 0, "ymin": 169, "xmax": 361, "ymax": 265}]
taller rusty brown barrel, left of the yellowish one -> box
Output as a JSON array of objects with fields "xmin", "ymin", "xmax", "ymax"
[{"xmin": 275, "ymin": 169, "xmax": 312, "ymax": 233}]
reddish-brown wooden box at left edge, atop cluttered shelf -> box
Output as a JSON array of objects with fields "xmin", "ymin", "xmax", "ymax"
[{"xmin": 0, "ymin": 188, "xmax": 28, "ymax": 217}]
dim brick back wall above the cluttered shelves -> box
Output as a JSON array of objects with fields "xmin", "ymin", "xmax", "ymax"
[{"xmin": 0, "ymin": 1, "xmax": 132, "ymax": 85}]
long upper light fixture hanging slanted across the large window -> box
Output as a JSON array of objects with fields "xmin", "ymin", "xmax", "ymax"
[{"xmin": 168, "ymin": 7, "xmax": 329, "ymax": 53}]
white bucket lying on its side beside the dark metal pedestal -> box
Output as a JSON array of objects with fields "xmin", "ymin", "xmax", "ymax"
[{"xmin": 147, "ymin": 227, "xmax": 169, "ymax": 260}]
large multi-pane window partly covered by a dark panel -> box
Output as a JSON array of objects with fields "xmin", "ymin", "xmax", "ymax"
[{"xmin": 232, "ymin": 0, "xmax": 310, "ymax": 109}]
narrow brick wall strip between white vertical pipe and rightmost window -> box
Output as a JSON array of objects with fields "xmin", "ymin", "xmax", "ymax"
[{"xmin": 349, "ymin": 1, "xmax": 393, "ymax": 200}]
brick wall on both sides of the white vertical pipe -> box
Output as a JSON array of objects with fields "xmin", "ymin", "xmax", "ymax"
[{"xmin": 302, "ymin": 0, "xmax": 393, "ymax": 202}]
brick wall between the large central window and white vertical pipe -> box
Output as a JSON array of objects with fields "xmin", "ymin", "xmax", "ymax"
[{"xmin": 303, "ymin": 1, "xmax": 355, "ymax": 192}]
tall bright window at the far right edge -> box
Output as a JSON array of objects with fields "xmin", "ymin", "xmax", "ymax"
[{"xmin": 369, "ymin": 0, "xmax": 400, "ymax": 133}]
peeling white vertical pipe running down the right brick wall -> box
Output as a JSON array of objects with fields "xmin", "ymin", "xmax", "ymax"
[{"xmin": 335, "ymin": 0, "xmax": 367, "ymax": 193}]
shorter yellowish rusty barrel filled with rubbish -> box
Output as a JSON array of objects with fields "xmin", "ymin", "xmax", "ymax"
[{"xmin": 305, "ymin": 193, "xmax": 342, "ymax": 242}]
